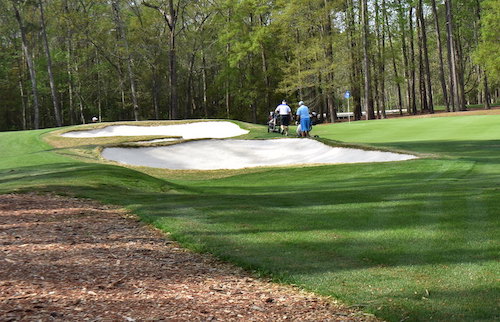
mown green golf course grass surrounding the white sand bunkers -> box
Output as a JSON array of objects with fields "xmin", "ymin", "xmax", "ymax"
[{"xmin": 0, "ymin": 115, "xmax": 500, "ymax": 321}]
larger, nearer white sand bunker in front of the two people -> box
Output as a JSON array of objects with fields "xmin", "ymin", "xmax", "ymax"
[{"xmin": 102, "ymin": 139, "xmax": 416, "ymax": 170}]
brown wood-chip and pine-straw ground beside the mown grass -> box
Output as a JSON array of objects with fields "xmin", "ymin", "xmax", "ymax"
[{"xmin": 0, "ymin": 194, "xmax": 375, "ymax": 321}]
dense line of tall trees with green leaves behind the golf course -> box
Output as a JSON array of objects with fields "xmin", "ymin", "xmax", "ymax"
[{"xmin": 0, "ymin": 0, "xmax": 500, "ymax": 130}]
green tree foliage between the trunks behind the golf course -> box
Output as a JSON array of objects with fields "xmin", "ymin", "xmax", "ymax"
[{"xmin": 0, "ymin": 0, "xmax": 500, "ymax": 130}]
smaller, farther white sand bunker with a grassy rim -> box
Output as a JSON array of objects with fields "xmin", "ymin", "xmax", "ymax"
[{"xmin": 62, "ymin": 121, "xmax": 248, "ymax": 140}]
